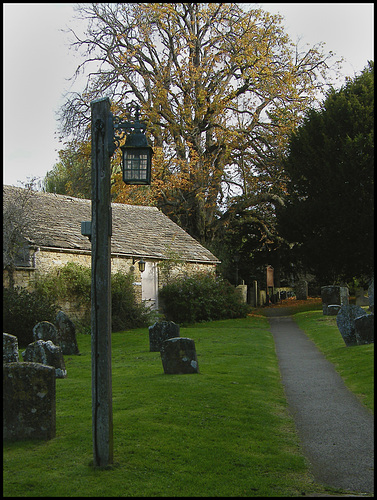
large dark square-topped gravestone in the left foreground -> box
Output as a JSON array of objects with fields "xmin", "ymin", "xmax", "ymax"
[{"xmin": 3, "ymin": 363, "xmax": 56, "ymax": 441}]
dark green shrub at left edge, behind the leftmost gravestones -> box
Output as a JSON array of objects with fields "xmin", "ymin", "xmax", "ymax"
[{"xmin": 3, "ymin": 287, "xmax": 59, "ymax": 347}]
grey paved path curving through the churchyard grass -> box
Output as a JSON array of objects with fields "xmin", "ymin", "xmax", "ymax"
[{"xmin": 265, "ymin": 308, "xmax": 374, "ymax": 493}]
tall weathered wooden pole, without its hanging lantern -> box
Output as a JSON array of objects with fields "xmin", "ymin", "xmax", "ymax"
[{"xmin": 91, "ymin": 98, "xmax": 113, "ymax": 467}]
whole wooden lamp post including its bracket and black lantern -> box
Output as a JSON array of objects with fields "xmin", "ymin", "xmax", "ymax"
[{"xmin": 88, "ymin": 98, "xmax": 153, "ymax": 467}]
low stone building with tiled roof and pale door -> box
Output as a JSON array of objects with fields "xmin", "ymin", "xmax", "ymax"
[{"xmin": 3, "ymin": 186, "xmax": 220, "ymax": 312}]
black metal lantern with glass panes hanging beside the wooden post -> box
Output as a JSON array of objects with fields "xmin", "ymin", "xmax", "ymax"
[{"xmin": 121, "ymin": 129, "xmax": 153, "ymax": 185}]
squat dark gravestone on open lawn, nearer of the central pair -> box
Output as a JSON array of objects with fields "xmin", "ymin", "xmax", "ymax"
[{"xmin": 160, "ymin": 337, "xmax": 199, "ymax": 375}]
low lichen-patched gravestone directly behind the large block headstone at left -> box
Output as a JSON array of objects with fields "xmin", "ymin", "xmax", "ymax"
[{"xmin": 22, "ymin": 340, "xmax": 67, "ymax": 378}]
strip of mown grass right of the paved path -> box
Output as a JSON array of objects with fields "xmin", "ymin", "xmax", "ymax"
[{"xmin": 293, "ymin": 310, "xmax": 374, "ymax": 411}]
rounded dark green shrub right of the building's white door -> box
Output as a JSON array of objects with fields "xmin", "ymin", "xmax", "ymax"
[{"xmin": 160, "ymin": 274, "xmax": 248, "ymax": 323}]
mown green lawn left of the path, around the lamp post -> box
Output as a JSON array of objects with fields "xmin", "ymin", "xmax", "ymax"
[{"xmin": 3, "ymin": 317, "xmax": 340, "ymax": 497}]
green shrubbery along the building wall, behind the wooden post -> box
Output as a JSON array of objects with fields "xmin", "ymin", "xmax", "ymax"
[{"xmin": 3, "ymin": 262, "xmax": 152, "ymax": 347}]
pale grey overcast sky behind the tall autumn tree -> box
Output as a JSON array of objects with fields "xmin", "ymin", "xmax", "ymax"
[{"xmin": 3, "ymin": 3, "xmax": 374, "ymax": 186}]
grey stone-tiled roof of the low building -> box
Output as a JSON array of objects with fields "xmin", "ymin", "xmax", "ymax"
[{"xmin": 3, "ymin": 186, "xmax": 219, "ymax": 264}]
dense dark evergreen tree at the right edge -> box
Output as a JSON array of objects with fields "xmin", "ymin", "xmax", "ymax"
[{"xmin": 279, "ymin": 62, "xmax": 374, "ymax": 284}]
